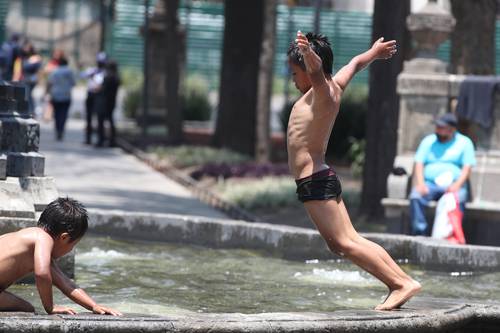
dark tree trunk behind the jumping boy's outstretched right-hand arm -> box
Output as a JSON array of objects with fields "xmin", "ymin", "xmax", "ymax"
[{"xmin": 360, "ymin": 0, "xmax": 411, "ymax": 219}]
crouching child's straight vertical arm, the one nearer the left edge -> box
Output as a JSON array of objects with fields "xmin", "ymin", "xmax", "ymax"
[{"xmin": 33, "ymin": 234, "xmax": 76, "ymax": 314}]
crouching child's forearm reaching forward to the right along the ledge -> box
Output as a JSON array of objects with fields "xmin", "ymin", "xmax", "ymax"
[{"xmin": 50, "ymin": 261, "xmax": 122, "ymax": 316}]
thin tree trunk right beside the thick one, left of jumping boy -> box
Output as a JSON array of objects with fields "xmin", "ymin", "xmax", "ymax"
[{"xmin": 255, "ymin": 0, "xmax": 276, "ymax": 163}]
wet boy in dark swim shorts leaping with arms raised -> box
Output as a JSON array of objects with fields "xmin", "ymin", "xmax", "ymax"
[{"xmin": 287, "ymin": 31, "xmax": 421, "ymax": 310}]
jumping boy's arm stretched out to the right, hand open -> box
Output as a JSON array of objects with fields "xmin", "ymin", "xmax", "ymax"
[{"xmin": 333, "ymin": 37, "xmax": 397, "ymax": 90}]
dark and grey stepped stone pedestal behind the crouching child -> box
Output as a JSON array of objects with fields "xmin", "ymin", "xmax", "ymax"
[{"xmin": 0, "ymin": 81, "xmax": 74, "ymax": 276}]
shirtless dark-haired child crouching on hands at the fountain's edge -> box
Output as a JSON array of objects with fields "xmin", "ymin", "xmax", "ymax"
[{"xmin": 0, "ymin": 198, "xmax": 121, "ymax": 316}]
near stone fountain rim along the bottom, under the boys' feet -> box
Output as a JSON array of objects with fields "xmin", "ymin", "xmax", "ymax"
[{"xmin": 0, "ymin": 299, "xmax": 500, "ymax": 333}]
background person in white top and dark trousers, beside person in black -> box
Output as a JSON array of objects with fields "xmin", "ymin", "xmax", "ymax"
[{"xmin": 81, "ymin": 52, "xmax": 107, "ymax": 145}]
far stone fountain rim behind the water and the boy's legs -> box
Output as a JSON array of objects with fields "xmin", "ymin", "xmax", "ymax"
[{"xmin": 89, "ymin": 209, "xmax": 500, "ymax": 271}]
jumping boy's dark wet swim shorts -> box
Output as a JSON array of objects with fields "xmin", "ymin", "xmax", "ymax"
[{"xmin": 295, "ymin": 168, "xmax": 342, "ymax": 202}]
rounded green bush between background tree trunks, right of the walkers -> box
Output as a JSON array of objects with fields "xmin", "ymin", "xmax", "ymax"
[{"xmin": 181, "ymin": 75, "xmax": 212, "ymax": 121}]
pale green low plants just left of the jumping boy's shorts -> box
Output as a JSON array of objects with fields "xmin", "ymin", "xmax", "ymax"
[{"xmin": 217, "ymin": 176, "xmax": 297, "ymax": 209}]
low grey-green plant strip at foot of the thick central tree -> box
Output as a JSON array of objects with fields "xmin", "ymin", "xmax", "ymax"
[{"xmin": 148, "ymin": 146, "xmax": 250, "ymax": 168}]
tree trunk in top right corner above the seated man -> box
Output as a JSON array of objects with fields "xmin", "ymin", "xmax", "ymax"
[{"xmin": 451, "ymin": 0, "xmax": 497, "ymax": 75}]
